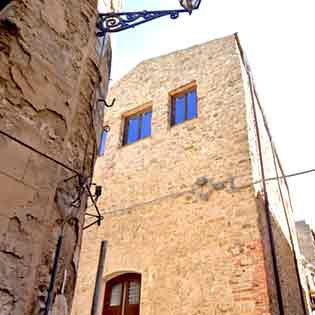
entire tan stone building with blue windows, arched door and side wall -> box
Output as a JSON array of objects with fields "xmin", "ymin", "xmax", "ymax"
[{"xmin": 72, "ymin": 35, "xmax": 308, "ymax": 315}]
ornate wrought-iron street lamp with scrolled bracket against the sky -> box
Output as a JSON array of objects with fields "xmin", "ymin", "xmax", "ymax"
[{"xmin": 96, "ymin": 0, "xmax": 201, "ymax": 37}]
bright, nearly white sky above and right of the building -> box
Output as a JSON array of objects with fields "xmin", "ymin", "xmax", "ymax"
[{"xmin": 100, "ymin": 0, "xmax": 315, "ymax": 226}]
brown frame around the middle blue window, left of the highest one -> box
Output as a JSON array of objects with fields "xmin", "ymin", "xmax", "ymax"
[{"xmin": 120, "ymin": 101, "xmax": 153, "ymax": 147}]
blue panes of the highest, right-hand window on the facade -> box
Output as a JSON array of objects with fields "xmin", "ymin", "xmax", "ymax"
[{"xmin": 171, "ymin": 87, "xmax": 198, "ymax": 126}]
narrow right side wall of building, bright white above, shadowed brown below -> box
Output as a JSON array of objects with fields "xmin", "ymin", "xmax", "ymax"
[{"xmin": 242, "ymin": 42, "xmax": 309, "ymax": 315}]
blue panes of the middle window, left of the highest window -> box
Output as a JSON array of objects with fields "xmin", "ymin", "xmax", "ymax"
[{"xmin": 123, "ymin": 108, "xmax": 152, "ymax": 145}]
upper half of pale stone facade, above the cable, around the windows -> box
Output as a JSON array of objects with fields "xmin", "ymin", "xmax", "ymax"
[{"xmin": 94, "ymin": 37, "xmax": 251, "ymax": 215}]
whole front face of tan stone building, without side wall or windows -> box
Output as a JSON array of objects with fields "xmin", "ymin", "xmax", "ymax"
[{"xmin": 73, "ymin": 36, "xmax": 277, "ymax": 315}]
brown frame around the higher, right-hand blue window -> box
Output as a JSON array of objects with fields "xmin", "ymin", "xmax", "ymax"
[{"xmin": 168, "ymin": 80, "xmax": 199, "ymax": 128}]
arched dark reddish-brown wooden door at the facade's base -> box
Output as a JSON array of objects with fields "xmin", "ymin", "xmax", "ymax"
[{"xmin": 103, "ymin": 273, "xmax": 141, "ymax": 315}]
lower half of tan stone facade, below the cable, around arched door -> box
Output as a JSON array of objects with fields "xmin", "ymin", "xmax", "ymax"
[{"xmin": 72, "ymin": 190, "xmax": 272, "ymax": 315}]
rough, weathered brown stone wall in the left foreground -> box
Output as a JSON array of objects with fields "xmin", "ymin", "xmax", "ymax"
[{"xmin": 0, "ymin": 0, "xmax": 110, "ymax": 315}]
